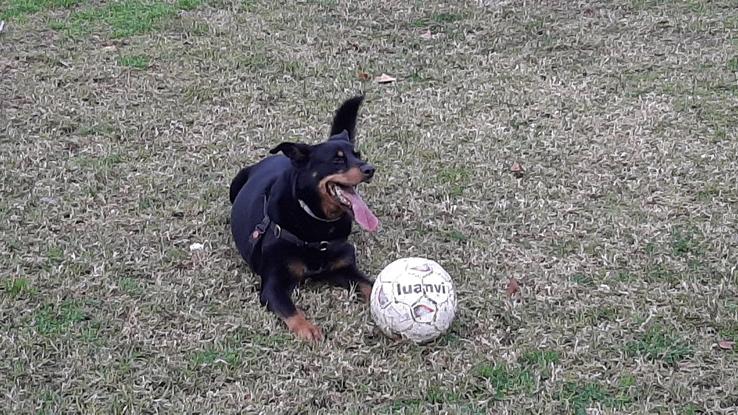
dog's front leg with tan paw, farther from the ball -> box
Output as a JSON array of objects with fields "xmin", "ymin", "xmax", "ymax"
[{"xmin": 259, "ymin": 274, "xmax": 323, "ymax": 342}]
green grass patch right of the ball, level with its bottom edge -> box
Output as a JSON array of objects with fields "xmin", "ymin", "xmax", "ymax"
[{"xmin": 625, "ymin": 324, "xmax": 694, "ymax": 364}]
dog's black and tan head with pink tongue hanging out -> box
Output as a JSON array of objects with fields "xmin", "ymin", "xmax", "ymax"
[{"xmin": 270, "ymin": 130, "xmax": 379, "ymax": 232}]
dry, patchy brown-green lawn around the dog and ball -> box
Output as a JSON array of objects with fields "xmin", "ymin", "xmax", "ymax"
[{"xmin": 0, "ymin": 0, "xmax": 738, "ymax": 414}]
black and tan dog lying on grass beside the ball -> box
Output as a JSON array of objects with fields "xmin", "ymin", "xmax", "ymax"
[{"xmin": 230, "ymin": 96, "xmax": 379, "ymax": 341}]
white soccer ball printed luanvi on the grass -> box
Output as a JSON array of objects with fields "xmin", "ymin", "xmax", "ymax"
[{"xmin": 371, "ymin": 258, "xmax": 456, "ymax": 344}]
